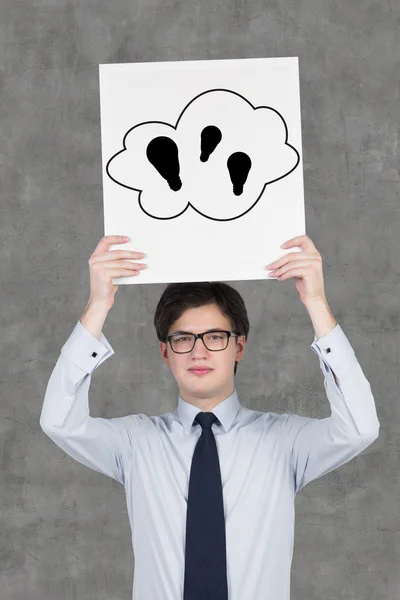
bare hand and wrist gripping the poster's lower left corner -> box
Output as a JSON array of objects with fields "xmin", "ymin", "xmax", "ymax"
[{"xmin": 80, "ymin": 235, "xmax": 147, "ymax": 339}]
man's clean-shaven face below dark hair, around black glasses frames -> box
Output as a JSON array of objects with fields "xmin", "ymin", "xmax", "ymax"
[{"xmin": 160, "ymin": 304, "xmax": 246, "ymax": 399}]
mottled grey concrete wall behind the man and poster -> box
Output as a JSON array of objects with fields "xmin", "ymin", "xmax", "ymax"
[{"xmin": 0, "ymin": 0, "xmax": 400, "ymax": 600}]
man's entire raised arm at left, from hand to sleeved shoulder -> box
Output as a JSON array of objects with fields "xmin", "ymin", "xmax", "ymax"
[{"xmin": 40, "ymin": 235, "xmax": 145, "ymax": 483}]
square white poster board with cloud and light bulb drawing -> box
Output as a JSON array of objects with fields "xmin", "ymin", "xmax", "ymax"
[{"xmin": 99, "ymin": 57, "xmax": 305, "ymax": 284}]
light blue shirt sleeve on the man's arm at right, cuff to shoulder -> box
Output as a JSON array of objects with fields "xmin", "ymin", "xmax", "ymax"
[{"xmin": 286, "ymin": 323, "xmax": 380, "ymax": 493}]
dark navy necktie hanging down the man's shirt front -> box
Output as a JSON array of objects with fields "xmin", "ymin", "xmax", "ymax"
[{"xmin": 183, "ymin": 412, "xmax": 228, "ymax": 600}]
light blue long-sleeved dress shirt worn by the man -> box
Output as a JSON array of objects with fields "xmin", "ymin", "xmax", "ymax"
[{"xmin": 40, "ymin": 321, "xmax": 379, "ymax": 600}]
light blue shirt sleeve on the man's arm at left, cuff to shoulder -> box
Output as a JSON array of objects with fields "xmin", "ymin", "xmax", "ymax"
[{"xmin": 40, "ymin": 321, "xmax": 137, "ymax": 485}]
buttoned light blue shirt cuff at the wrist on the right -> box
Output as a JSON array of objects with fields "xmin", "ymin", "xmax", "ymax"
[{"xmin": 311, "ymin": 323, "xmax": 355, "ymax": 370}]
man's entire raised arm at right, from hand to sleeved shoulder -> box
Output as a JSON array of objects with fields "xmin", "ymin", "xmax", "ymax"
[{"xmin": 267, "ymin": 235, "xmax": 379, "ymax": 492}]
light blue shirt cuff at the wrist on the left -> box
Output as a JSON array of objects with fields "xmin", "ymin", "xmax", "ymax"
[{"xmin": 61, "ymin": 320, "xmax": 114, "ymax": 374}]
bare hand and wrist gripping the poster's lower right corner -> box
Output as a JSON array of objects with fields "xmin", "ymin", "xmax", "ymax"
[{"xmin": 266, "ymin": 235, "xmax": 336, "ymax": 338}]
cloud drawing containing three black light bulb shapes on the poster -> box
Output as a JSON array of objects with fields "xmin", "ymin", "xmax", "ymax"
[{"xmin": 106, "ymin": 89, "xmax": 300, "ymax": 221}]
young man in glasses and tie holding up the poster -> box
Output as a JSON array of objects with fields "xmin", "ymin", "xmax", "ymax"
[{"xmin": 40, "ymin": 236, "xmax": 379, "ymax": 600}]
